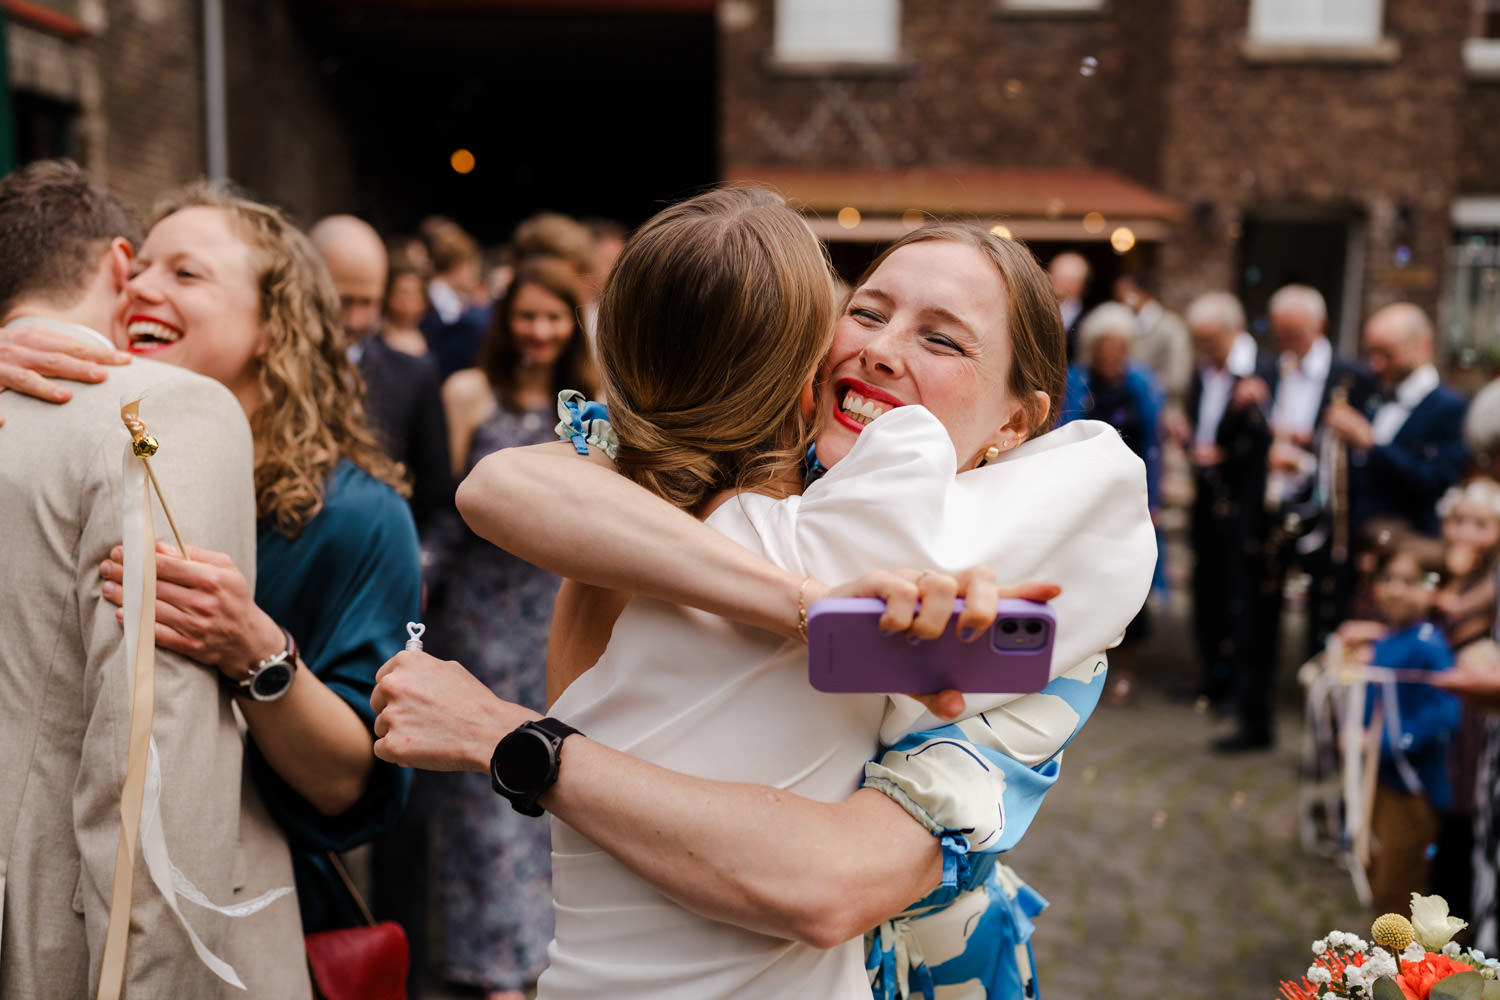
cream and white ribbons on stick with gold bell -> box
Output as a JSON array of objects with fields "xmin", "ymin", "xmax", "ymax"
[{"xmin": 99, "ymin": 400, "xmax": 293, "ymax": 1000}]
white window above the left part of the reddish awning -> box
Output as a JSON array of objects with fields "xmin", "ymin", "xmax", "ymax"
[{"xmin": 776, "ymin": 0, "xmax": 902, "ymax": 64}]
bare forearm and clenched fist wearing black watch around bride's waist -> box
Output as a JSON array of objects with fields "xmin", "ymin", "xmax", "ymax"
[{"xmin": 372, "ymin": 652, "xmax": 942, "ymax": 948}]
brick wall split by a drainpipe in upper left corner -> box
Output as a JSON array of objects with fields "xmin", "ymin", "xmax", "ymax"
[{"xmin": 0, "ymin": 0, "xmax": 354, "ymax": 219}]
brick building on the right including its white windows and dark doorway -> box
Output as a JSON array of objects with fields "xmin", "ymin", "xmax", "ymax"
[{"xmin": 720, "ymin": 0, "xmax": 1500, "ymax": 361}]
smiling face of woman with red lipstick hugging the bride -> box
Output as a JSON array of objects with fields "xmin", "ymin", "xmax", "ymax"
[{"xmin": 818, "ymin": 240, "xmax": 1026, "ymax": 471}]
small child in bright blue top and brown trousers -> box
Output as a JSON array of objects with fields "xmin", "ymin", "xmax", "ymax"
[{"xmin": 1340, "ymin": 535, "xmax": 1458, "ymax": 913}]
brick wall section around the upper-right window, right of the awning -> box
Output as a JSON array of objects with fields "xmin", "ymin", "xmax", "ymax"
[{"xmin": 1163, "ymin": 0, "xmax": 1469, "ymax": 322}]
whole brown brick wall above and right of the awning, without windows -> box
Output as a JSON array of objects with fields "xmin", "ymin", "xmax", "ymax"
[{"xmin": 720, "ymin": 0, "xmax": 1476, "ymax": 329}]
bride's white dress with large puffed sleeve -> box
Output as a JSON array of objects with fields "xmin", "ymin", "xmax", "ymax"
[{"xmin": 539, "ymin": 406, "xmax": 1155, "ymax": 1000}]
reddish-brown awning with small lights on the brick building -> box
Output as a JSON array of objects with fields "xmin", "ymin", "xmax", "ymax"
[{"xmin": 725, "ymin": 166, "xmax": 1185, "ymax": 243}]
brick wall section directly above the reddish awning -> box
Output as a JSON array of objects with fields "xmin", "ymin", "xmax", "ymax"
[{"xmin": 720, "ymin": 0, "xmax": 1134, "ymax": 172}]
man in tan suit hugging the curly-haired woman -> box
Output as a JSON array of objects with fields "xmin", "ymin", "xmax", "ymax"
[{"xmin": 0, "ymin": 162, "xmax": 311, "ymax": 1000}]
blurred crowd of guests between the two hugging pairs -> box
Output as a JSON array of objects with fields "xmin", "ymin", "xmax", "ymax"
[{"xmin": 309, "ymin": 205, "xmax": 627, "ymax": 1000}]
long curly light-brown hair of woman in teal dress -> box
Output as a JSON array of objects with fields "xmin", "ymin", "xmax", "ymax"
[{"xmin": 152, "ymin": 183, "xmax": 410, "ymax": 538}]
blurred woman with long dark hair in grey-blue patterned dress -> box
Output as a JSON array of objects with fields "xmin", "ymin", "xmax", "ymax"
[{"xmin": 428, "ymin": 258, "xmax": 594, "ymax": 1000}]
